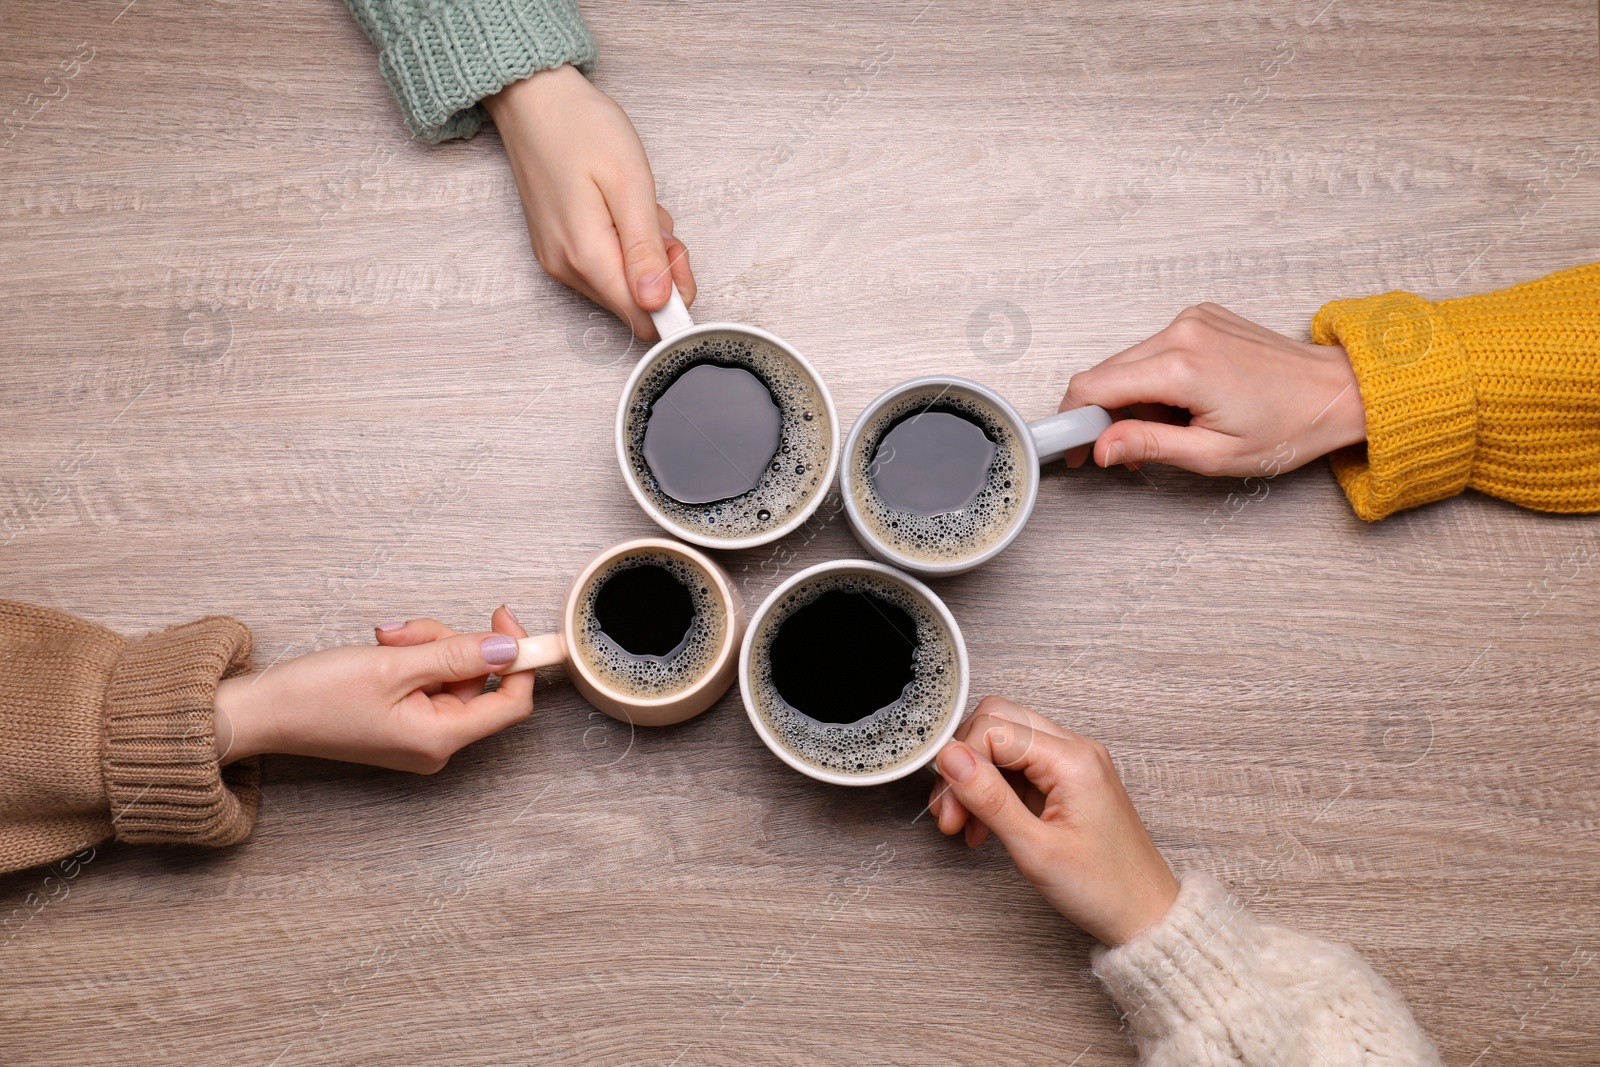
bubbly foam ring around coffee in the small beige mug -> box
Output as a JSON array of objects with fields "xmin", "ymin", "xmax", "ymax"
[{"xmin": 573, "ymin": 549, "xmax": 728, "ymax": 699}]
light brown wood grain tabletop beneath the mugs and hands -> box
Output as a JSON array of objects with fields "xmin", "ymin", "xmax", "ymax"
[{"xmin": 0, "ymin": 0, "xmax": 1600, "ymax": 1067}]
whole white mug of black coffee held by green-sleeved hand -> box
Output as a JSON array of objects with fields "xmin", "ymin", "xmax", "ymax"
[{"xmin": 616, "ymin": 288, "xmax": 838, "ymax": 549}]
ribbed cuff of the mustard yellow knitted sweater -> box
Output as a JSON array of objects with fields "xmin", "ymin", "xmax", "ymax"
[{"xmin": 1310, "ymin": 293, "xmax": 1478, "ymax": 520}]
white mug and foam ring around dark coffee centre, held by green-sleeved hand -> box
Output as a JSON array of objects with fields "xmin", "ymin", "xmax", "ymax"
[{"xmin": 616, "ymin": 286, "xmax": 838, "ymax": 550}]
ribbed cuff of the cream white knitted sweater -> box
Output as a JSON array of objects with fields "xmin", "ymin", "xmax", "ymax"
[{"xmin": 1091, "ymin": 873, "xmax": 1270, "ymax": 1046}]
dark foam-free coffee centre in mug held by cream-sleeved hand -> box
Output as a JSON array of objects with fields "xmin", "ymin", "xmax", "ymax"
[{"xmin": 771, "ymin": 589, "xmax": 917, "ymax": 723}]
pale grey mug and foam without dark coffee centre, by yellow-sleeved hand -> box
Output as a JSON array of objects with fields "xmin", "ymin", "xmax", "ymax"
[{"xmin": 840, "ymin": 376, "xmax": 1112, "ymax": 577}]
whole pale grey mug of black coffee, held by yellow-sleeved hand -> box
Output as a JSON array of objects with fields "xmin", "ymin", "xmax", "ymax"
[{"xmin": 840, "ymin": 376, "xmax": 1112, "ymax": 577}]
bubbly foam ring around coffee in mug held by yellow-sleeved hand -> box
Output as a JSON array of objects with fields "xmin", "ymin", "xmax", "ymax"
[{"xmin": 845, "ymin": 386, "xmax": 1038, "ymax": 563}]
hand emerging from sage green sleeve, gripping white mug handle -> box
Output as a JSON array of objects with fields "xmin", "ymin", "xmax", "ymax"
[{"xmin": 483, "ymin": 66, "xmax": 694, "ymax": 339}]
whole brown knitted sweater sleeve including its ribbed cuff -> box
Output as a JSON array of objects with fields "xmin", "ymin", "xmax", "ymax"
[{"xmin": 0, "ymin": 600, "xmax": 261, "ymax": 872}]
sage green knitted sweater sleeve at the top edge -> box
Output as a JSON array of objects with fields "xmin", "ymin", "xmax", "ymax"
[{"xmin": 346, "ymin": 0, "xmax": 597, "ymax": 144}]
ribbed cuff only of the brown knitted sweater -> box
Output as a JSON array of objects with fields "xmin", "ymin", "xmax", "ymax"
[{"xmin": 102, "ymin": 617, "xmax": 261, "ymax": 845}]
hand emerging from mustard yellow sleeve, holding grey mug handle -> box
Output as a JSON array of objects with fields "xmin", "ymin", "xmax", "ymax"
[{"xmin": 1061, "ymin": 304, "xmax": 1366, "ymax": 477}]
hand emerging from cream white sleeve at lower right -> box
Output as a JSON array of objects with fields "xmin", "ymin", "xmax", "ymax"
[{"xmin": 928, "ymin": 696, "xmax": 1178, "ymax": 945}]
